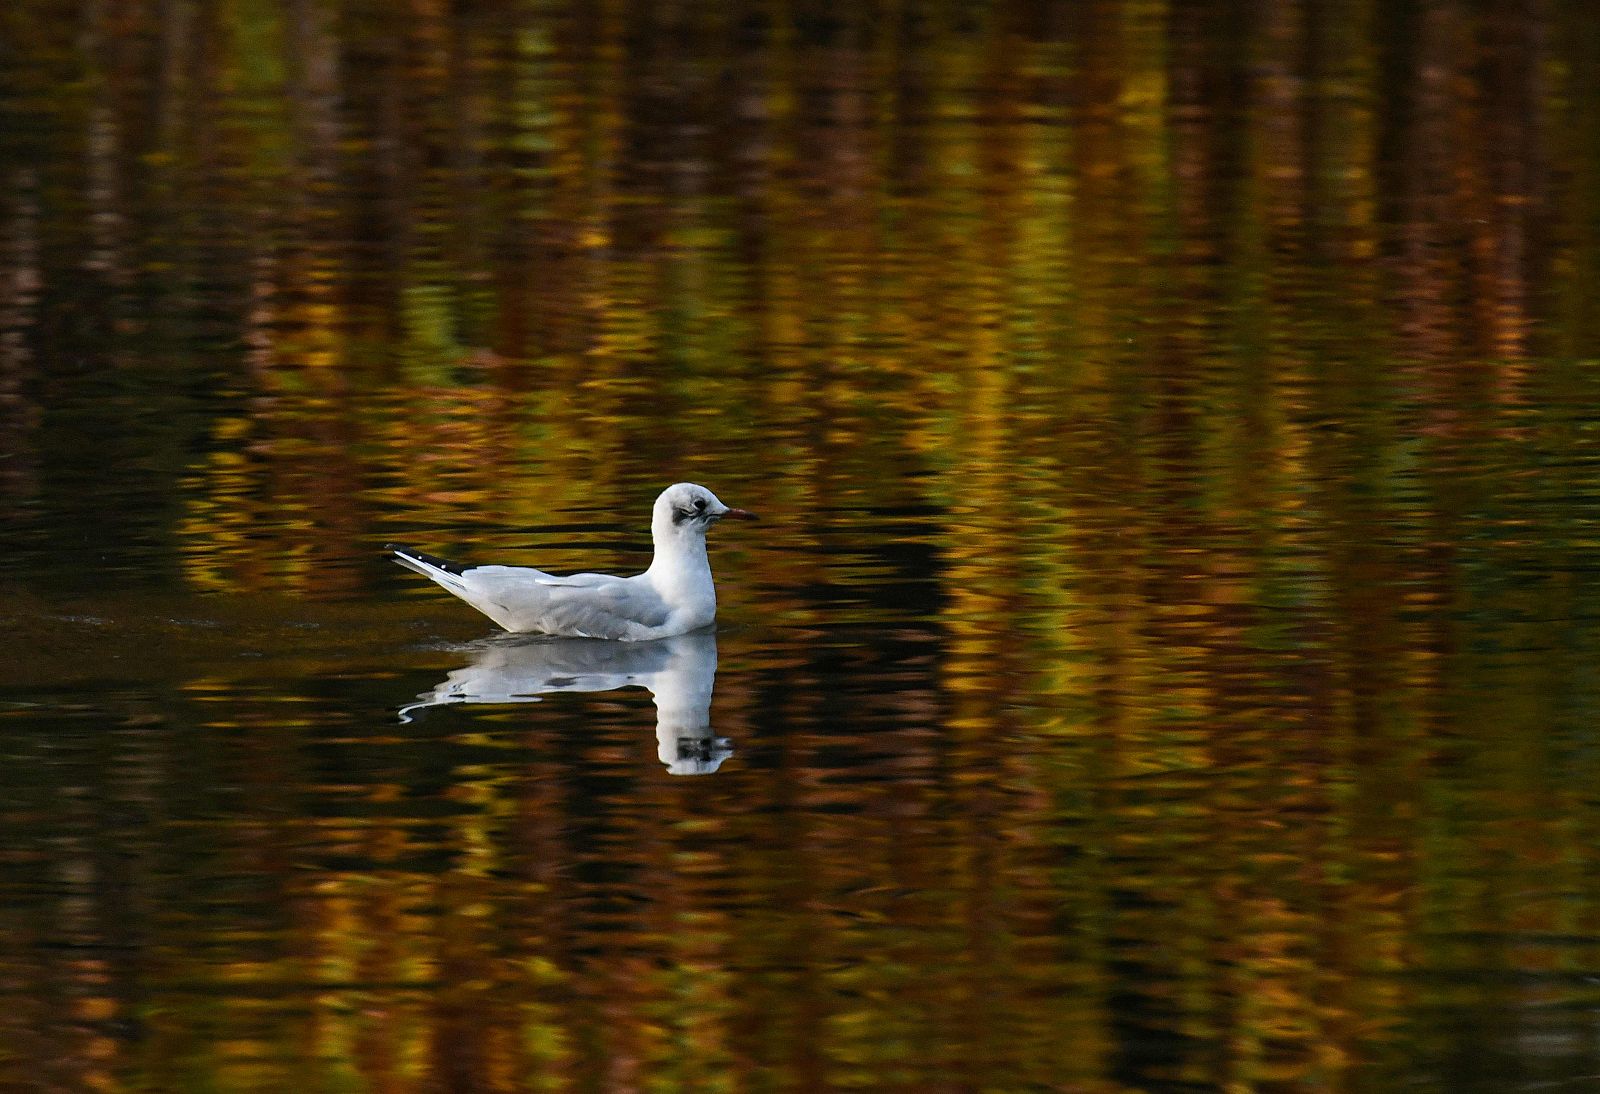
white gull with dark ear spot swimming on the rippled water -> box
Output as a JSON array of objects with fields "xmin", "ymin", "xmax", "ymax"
[{"xmin": 386, "ymin": 483, "xmax": 755, "ymax": 641}]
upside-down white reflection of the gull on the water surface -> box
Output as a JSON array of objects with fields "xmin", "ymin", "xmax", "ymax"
[{"xmin": 400, "ymin": 630, "xmax": 733, "ymax": 774}]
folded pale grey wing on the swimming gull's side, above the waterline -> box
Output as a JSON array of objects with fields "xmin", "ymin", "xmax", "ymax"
[{"xmin": 461, "ymin": 566, "xmax": 672, "ymax": 638}]
